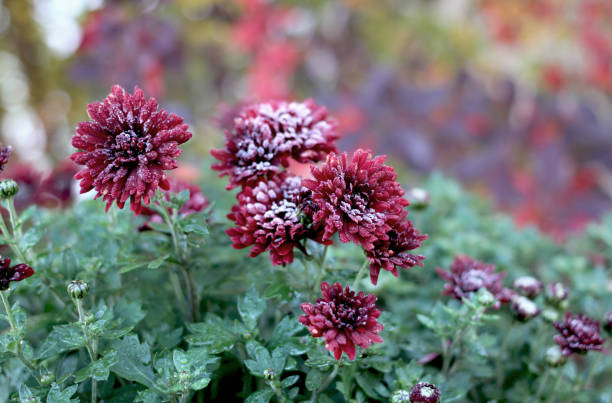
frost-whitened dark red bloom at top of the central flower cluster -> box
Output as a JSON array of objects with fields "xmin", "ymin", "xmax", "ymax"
[{"xmin": 211, "ymin": 100, "xmax": 338, "ymax": 189}]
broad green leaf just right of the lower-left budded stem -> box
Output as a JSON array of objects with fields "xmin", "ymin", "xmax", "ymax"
[{"xmin": 111, "ymin": 335, "xmax": 155, "ymax": 389}]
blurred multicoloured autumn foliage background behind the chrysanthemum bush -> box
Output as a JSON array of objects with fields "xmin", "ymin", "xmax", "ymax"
[{"xmin": 0, "ymin": 0, "xmax": 612, "ymax": 240}]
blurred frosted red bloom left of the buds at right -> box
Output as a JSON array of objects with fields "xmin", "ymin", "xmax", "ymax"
[{"xmin": 436, "ymin": 256, "xmax": 513, "ymax": 309}]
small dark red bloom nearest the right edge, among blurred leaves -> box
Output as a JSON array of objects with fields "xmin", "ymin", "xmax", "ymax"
[{"xmin": 553, "ymin": 312, "xmax": 605, "ymax": 357}]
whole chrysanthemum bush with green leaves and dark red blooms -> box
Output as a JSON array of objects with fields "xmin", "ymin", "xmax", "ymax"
[{"xmin": 0, "ymin": 86, "xmax": 612, "ymax": 403}]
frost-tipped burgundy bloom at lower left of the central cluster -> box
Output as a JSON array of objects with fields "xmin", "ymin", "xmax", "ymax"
[{"xmin": 226, "ymin": 175, "xmax": 328, "ymax": 265}]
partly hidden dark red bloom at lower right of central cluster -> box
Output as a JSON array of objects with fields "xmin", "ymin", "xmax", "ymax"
[{"xmin": 366, "ymin": 214, "xmax": 427, "ymax": 285}]
